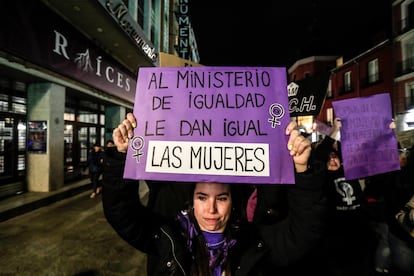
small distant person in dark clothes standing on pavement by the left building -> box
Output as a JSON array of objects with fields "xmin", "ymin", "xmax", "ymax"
[{"xmin": 86, "ymin": 143, "xmax": 103, "ymax": 198}]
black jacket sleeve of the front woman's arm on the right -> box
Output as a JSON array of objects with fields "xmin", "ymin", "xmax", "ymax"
[{"xmin": 259, "ymin": 162, "xmax": 327, "ymax": 266}]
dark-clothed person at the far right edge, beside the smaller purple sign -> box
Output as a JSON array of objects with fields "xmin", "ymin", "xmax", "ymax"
[{"xmin": 364, "ymin": 147, "xmax": 414, "ymax": 276}]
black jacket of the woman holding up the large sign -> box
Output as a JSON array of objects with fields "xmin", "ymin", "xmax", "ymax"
[{"xmin": 102, "ymin": 154, "xmax": 326, "ymax": 275}]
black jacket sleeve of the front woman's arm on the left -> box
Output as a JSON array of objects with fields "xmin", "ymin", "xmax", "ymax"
[{"xmin": 102, "ymin": 152, "xmax": 162, "ymax": 253}]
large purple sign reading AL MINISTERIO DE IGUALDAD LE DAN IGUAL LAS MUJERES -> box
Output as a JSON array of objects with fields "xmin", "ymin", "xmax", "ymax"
[{"xmin": 124, "ymin": 66, "xmax": 294, "ymax": 184}]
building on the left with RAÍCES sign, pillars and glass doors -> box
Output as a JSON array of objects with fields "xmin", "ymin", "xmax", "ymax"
[{"xmin": 0, "ymin": 0, "xmax": 199, "ymax": 199}]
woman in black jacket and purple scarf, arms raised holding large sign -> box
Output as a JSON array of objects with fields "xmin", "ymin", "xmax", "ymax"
[{"xmin": 103, "ymin": 114, "xmax": 326, "ymax": 275}]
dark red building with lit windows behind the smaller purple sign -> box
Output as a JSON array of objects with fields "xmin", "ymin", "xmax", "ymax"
[{"xmin": 289, "ymin": 40, "xmax": 394, "ymax": 141}]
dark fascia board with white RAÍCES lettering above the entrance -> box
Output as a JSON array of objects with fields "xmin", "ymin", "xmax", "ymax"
[{"xmin": 0, "ymin": 1, "xmax": 136, "ymax": 102}]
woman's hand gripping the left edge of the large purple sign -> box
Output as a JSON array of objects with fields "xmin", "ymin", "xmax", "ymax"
[{"xmin": 112, "ymin": 113, "xmax": 137, "ymax": 153}]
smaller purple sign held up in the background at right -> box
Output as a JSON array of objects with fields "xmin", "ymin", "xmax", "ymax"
[{"xmin": 332, "ymin": 93, "xmax": 400, "ymax": 179}]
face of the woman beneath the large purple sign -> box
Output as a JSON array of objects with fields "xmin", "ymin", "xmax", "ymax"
[{"xmin": 193, "ymin": 182, "xmax": 232, "ymax": 233}]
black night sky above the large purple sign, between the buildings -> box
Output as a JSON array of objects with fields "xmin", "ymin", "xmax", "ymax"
[{"xmin": 189, "ymin": 0, "xmax": 391, "ymax": 67}]
